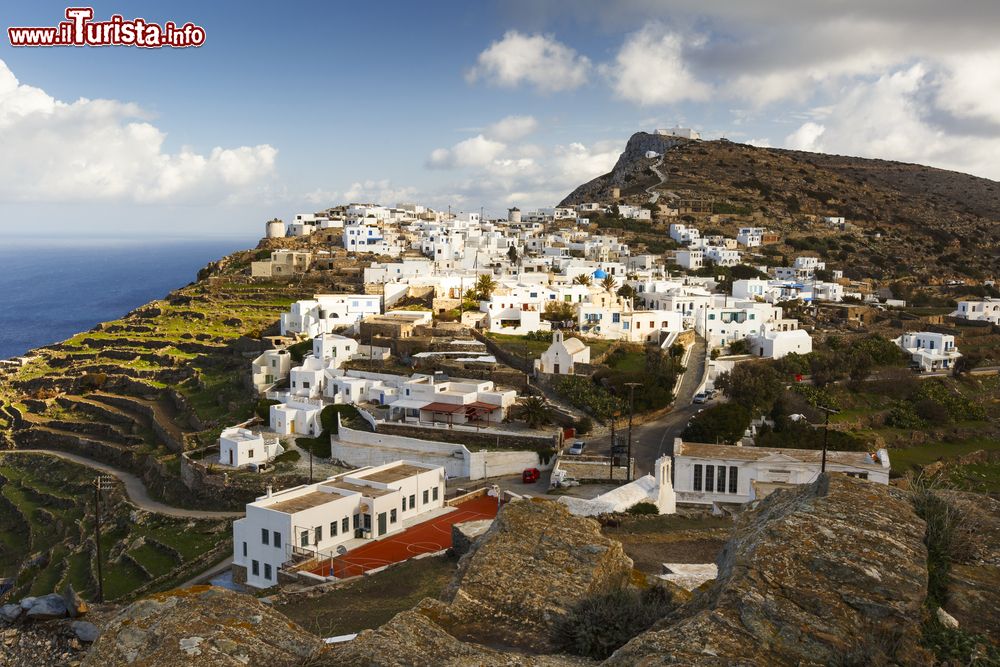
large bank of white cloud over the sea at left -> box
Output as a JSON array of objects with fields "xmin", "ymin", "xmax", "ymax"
[{"xmin": 0, "ymin": 60, "xmax": 277, "ymax": 203}]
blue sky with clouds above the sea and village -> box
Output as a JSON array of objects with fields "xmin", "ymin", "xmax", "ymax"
[{"xmin": 0, "ymin": 0, "xmax": 1000, "ymax": 243}]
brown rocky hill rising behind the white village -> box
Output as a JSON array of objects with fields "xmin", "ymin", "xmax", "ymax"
[{"xmin": 562, "ymin": 132, "xmax": 1000, "ymax": 279}]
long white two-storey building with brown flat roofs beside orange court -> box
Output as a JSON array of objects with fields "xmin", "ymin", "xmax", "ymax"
[{"xmin": 233, "ymin": 461, "xmax": 445, "ymax": 588}]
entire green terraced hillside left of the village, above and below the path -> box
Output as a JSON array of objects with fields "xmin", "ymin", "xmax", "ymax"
[{"xmin": 0, "ymin": 252, "xmax": 372, "ymax": 599}]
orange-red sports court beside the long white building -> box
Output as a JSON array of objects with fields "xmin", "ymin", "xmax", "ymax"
[{"xmin": 312, "ymin": 496, "xmax": 497, "ymax": 579}]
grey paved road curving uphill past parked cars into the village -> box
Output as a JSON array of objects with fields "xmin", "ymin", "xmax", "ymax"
[{"xmin": 588, "ymin": 336, "xmax": 705, "ymax": 477}]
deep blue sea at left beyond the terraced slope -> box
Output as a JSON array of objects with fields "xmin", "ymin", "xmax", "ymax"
[{"xmin": 0, "ymin": 235, "xmax": 256, "ymax": 359}]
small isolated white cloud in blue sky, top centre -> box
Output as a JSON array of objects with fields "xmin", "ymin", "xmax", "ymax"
[{"xmin": 466, "ymin": 30, "xmax": 591, "ymax": 92}]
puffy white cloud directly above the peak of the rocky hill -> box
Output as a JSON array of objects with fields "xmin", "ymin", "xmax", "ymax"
[{"xmin": 601, "ymin": 23, "xmax": 712, "ymax": 105}]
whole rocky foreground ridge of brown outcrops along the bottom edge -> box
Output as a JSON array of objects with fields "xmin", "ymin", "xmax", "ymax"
[{"xmin": 66, "ymin": 475, "xmax": 1000, "ymax": 666}]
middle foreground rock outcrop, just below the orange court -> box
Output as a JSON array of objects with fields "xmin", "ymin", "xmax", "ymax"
[{"xmin": 329, "ymin": 500, "xmax": 632, "ymax": 665}]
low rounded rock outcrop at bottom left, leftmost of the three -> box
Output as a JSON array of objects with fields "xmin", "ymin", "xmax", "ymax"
[{"xmin": 83, "ymin": 586, "xmax": 323, "ymax": 667}]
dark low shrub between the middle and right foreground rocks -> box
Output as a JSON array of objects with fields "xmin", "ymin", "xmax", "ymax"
[{"xmin": 553, "ymin": 586, "xmax": 674, "ymax": 660}]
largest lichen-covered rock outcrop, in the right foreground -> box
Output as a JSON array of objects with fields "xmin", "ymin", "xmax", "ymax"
[{"xmin": 608, "ymin": 475, "xmax": 932, "ymax": 665}]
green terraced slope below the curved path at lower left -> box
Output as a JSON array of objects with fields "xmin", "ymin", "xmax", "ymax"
[{"xmin": 0, "ymin": 453, "xmax": 231, "ymax": 600}]
